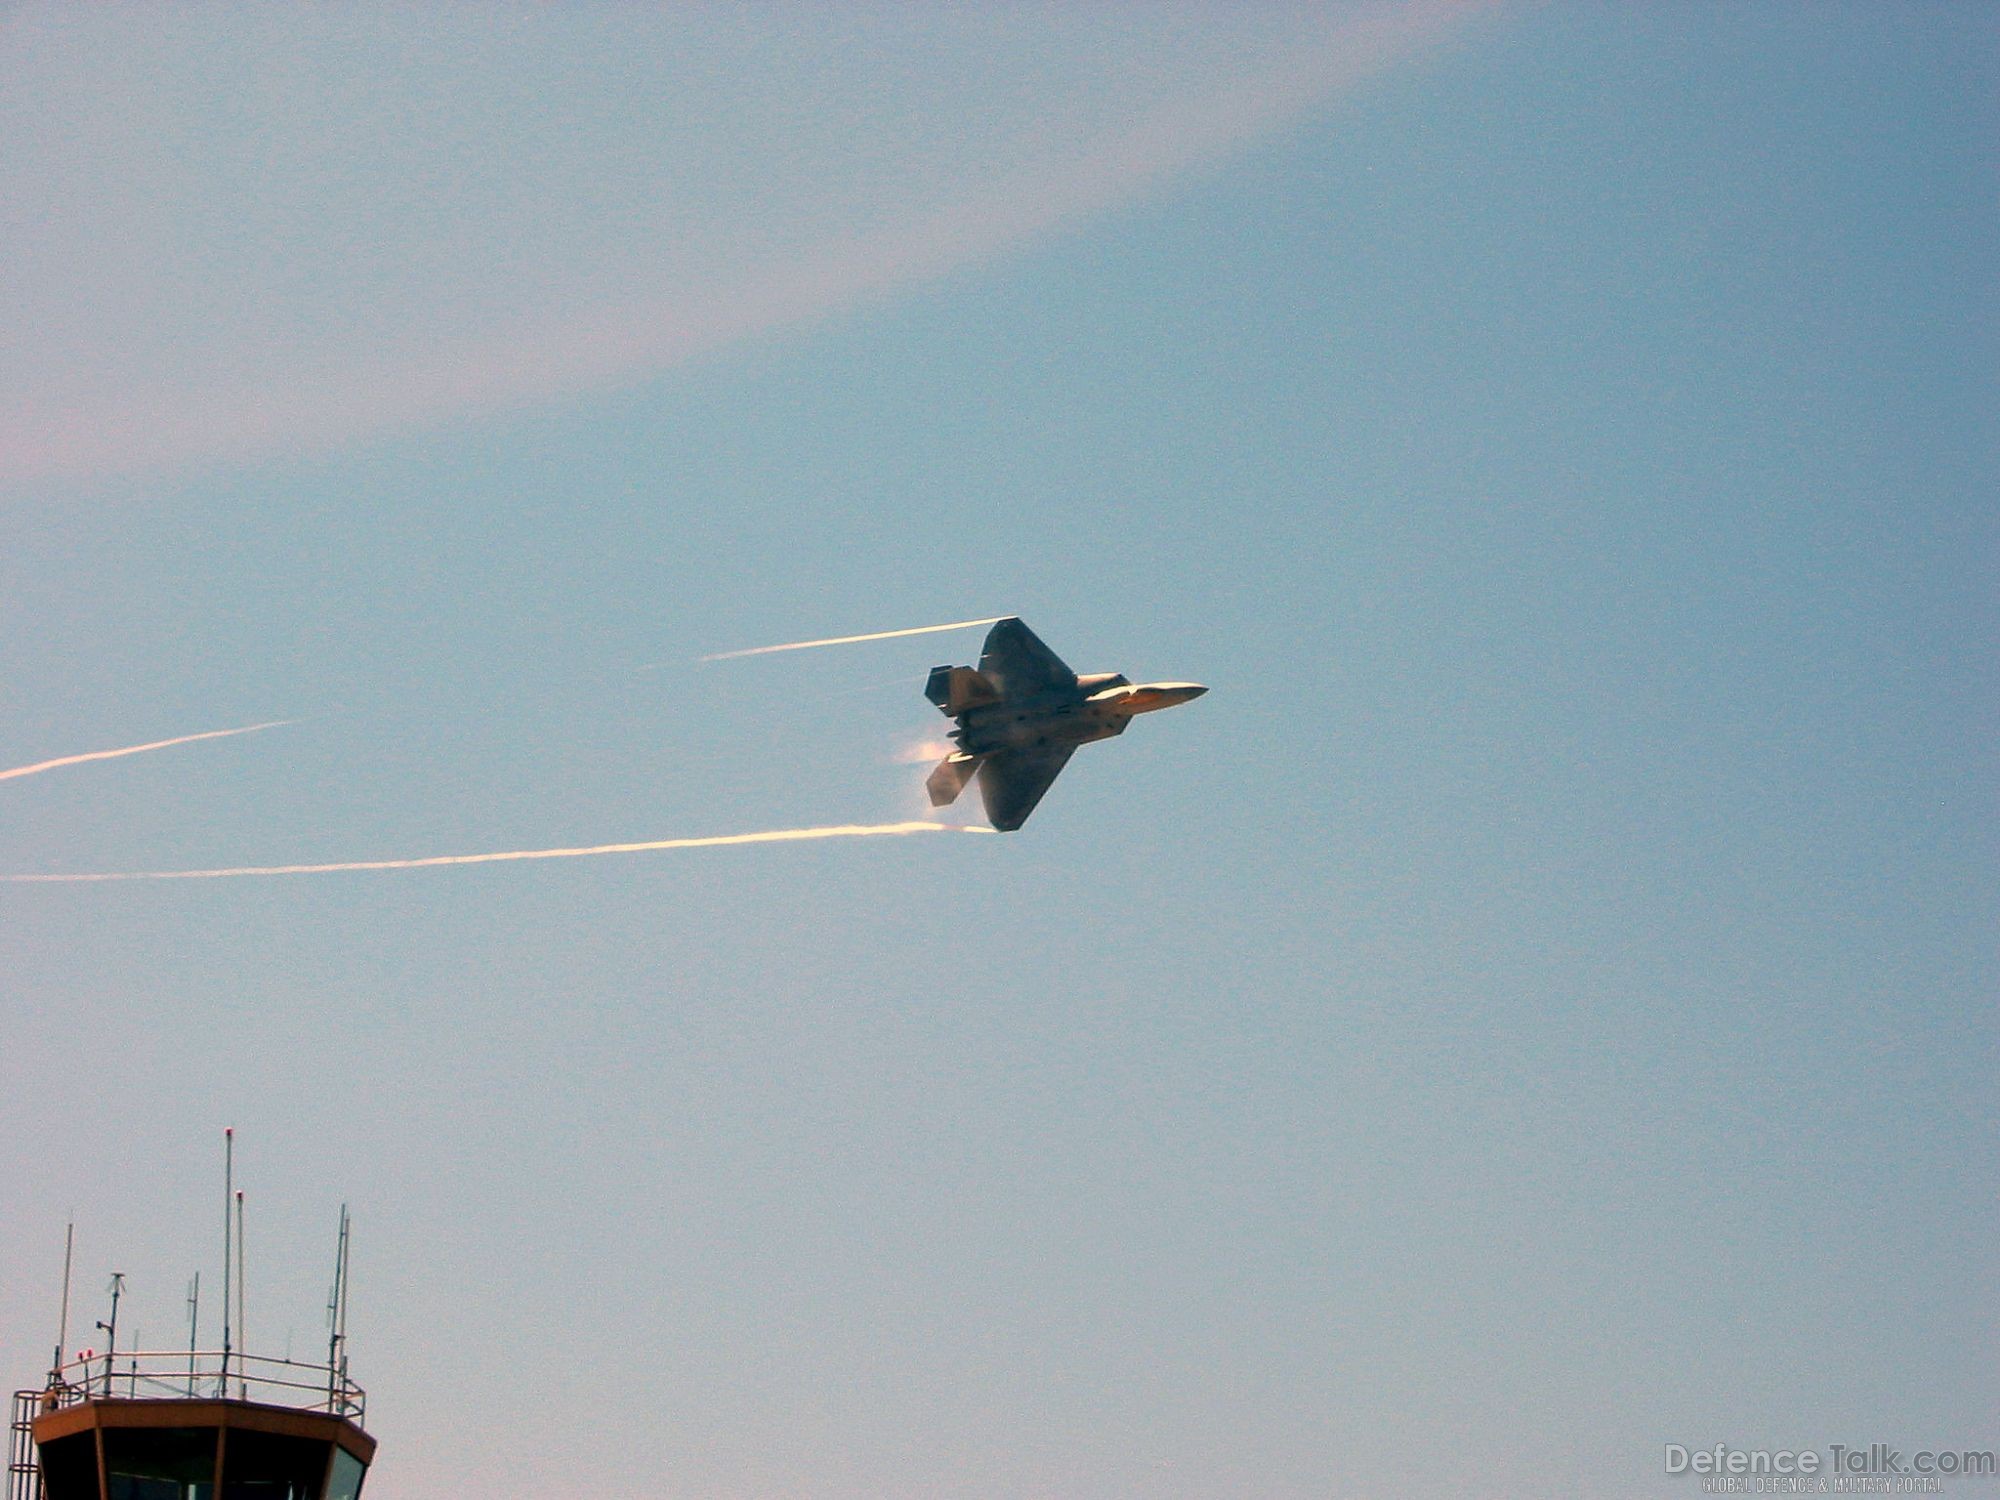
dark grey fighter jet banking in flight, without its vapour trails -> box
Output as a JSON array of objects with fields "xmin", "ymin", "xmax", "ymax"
[{"xmin": 924, "ymin": 618, "xmax": 1208, "ymax": 832}]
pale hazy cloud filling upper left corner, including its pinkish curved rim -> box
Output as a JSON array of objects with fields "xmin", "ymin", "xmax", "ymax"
[{"xmin": 0, "ymin": 0, "xmax": 1468, "ymax": 482}]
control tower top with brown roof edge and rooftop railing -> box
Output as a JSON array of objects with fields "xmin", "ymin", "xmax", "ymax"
[{"xmin": 8, "ymin": 1350, "xmax": 376, "ymax": 1500}]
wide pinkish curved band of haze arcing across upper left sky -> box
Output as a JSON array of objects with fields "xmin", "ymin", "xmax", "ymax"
[{"xmin": 0, "ymin": 0, "xmax": 1490, "ymax": 482}]
